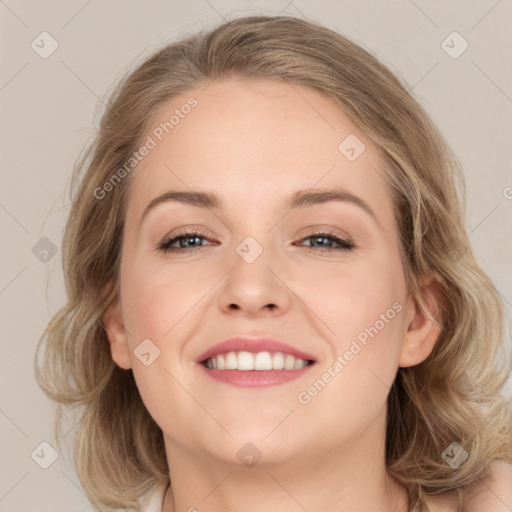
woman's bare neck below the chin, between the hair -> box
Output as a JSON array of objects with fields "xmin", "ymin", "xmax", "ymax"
[{"xmin": 162, "ymin": 406, "xmax": 409, "ymax": 512}]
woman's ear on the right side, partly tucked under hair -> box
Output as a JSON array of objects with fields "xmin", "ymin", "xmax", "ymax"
[{"xmin": 398, "ymin": 272, "xmax": 443, "ymax": 368}]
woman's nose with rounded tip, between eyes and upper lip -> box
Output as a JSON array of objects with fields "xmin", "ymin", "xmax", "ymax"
[{"xmin": 218, "ymin": 242, "xmax": 292, "ymax": 317}]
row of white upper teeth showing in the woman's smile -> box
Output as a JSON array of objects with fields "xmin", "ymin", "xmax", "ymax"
[{"xmin": 206, "ymin": 351, "xmax": 308, "ymax": 371}]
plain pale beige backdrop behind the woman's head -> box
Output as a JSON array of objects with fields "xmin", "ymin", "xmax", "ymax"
[{"xmin": 0, "ymin": 0, "xmax": 512, "ymax": 512}]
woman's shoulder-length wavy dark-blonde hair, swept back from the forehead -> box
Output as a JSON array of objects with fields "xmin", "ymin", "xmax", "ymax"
[{"xmin": 34, "ymin": 16, "xmax": 512, "ymax": 511}]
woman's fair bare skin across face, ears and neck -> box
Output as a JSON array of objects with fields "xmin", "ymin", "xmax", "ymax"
[{"xmin": 103, "ymin": 79, "xmax": 510, "ymax": 512}]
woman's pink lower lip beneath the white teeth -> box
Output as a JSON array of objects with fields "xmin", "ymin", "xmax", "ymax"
[{"xmin": 199, "ymin": 364, "xmax": 314, "ymax": 388}]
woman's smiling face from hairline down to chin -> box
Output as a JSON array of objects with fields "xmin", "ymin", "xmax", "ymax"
[{"xmin": 111, "ymin": 80, "xmax": 424, "ymax": 463}]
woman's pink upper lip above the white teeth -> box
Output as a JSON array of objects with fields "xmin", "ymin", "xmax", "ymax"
[{"xmin": 196, "ymin": 336, "xmax": 315, "ymax": 363}]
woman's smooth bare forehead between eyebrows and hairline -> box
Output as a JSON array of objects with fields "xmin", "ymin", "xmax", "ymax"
[{"xmin": 128, "ymin": 79, "xmax": 392, "ymax": 224}]
